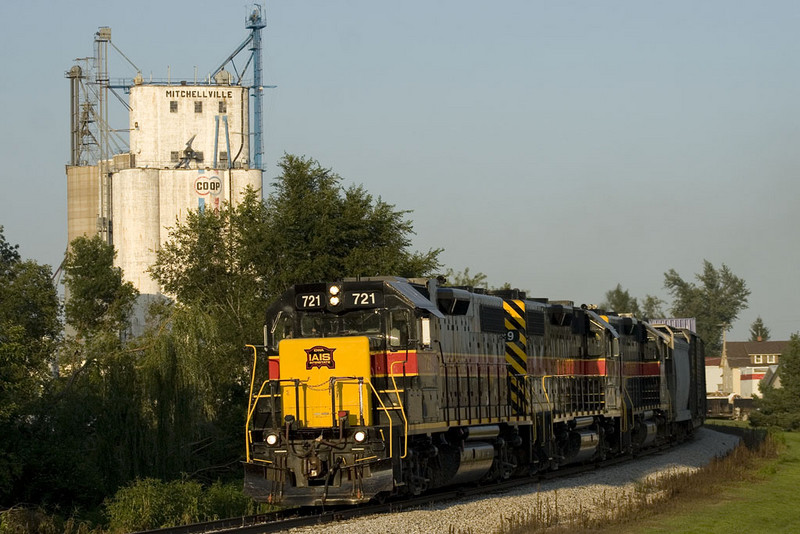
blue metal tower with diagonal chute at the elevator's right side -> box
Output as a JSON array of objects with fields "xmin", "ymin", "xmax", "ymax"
[{"xmin": 211, "ymin": 4, "xmax": 275, "ymax": 170}]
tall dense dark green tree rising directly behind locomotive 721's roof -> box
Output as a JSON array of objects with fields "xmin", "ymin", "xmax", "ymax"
[{"xmin": 264, "ymin": 154, "xmax": 441, "ymax": 295}]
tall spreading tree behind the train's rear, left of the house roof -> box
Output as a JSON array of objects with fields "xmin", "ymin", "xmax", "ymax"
[{"xmin": 664, "ymin": 260, "xmax": 750, "ymax": 355}]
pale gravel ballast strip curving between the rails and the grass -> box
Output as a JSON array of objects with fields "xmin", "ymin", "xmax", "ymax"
[{"xmin": 290, "ymin": 428, "xmax": 739, "ymax": 534}]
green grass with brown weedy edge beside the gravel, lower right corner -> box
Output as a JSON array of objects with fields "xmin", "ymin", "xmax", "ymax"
[{"xmin": 496, "ymin": 429, "xmax": 800, "ymax": 534}]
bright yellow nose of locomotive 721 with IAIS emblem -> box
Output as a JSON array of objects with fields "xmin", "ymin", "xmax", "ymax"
[{"xmin": 278, "ymin": 336, "xmax": 372, "ymax": 428}]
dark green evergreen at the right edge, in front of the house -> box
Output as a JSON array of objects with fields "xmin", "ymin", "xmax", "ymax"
[{"xmin": 750, "ymin": 334, "xmax": 800, "ymax": 430}]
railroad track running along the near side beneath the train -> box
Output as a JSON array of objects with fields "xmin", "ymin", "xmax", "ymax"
[{"xmin": 134, "ymin": 444, "xmax": 677, "ymax": 534}]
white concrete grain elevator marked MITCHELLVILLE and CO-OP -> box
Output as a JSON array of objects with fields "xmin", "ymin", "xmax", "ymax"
[{"xmin": 66, "ymin": 6, "xmax": 265, "ymax": 333}]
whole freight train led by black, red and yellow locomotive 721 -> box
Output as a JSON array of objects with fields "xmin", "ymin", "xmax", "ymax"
[{"xmin": 244, "ymin": 277, "xmax": 706, "ymax": 506}]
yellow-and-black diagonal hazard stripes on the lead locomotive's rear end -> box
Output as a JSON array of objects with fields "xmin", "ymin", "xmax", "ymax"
[{"xmin": 503, "ymin": 300, "xmax": 528, "ymax": 415}]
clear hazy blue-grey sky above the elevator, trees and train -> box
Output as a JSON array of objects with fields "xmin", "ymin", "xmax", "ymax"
[{"xmin": 0, "ymin": 0, "xmax": 800, "ymax": 340}]
